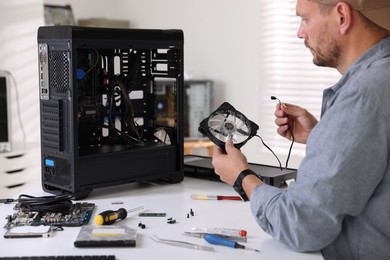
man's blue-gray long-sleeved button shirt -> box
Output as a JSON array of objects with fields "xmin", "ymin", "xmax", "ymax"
[{"xmin": 250, "ymin": 37, "xmax": 390, "ymax": 260}]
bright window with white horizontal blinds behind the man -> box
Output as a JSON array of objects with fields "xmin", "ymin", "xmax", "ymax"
[{"xmin": 256, "ymin": 0, "xmax": 341, "ymax": 167}]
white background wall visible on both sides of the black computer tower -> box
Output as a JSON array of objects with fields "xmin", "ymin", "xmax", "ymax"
[{"xmin": 0, "ymin": 0, "xmax": 280, "ymax": 167}]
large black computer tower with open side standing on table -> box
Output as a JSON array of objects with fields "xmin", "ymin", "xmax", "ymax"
[{"xmin": 38, "ymin": 26, "xmax": 184, "ymax": 198}]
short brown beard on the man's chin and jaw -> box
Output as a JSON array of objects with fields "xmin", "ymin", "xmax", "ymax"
[{"xmin": 305, "ymin": 34, "xmax": 341, "ymax": 68}]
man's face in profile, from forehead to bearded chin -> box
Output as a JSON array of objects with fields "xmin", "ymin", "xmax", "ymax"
[{"xmin": 296, "ymin": 0, "xmax": 341, "ymax": 68}]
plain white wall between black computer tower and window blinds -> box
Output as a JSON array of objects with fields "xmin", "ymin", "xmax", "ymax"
[{"xmin": 44, "ymin": 0, "xmax": 258, "ymax": 110}]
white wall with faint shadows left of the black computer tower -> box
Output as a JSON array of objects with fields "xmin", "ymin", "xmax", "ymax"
[{"xmin": 0, "ymin": 0, "xmax": 43, "ymax": 147}]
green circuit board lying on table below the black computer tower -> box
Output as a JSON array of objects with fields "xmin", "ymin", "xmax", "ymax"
[{"xmin": 4, "ymin": 202, "xmax": 95, "ymax": 229}]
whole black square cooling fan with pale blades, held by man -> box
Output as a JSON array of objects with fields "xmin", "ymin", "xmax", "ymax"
[{"xmin": 199, "ymin": 102, "xmax": 259, "ymax": 149}]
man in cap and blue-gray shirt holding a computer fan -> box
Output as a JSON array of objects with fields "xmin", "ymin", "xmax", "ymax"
[{"xmin": 212, "ymin": 0, "xmax": 390, "ymax": 260}]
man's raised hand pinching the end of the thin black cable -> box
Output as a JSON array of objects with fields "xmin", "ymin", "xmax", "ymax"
[{"xmin": 275, "ymin": 103, "xmax": 318, "ymax": 144}]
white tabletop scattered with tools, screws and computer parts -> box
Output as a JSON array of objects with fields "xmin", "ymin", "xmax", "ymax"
[{"xmin": 0, "ymin": 177, "xmax": 323, "ymax": 260}]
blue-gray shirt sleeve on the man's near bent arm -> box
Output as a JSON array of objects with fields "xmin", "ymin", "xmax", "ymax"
[{"xmin": 250, "ymin": 85, "xmax": 389, "ymax": 251}]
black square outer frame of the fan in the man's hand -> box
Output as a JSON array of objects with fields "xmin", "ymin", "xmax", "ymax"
[{"xmin": 198, "ymin": 102, "xmax": 259, "ymax": 150}]
